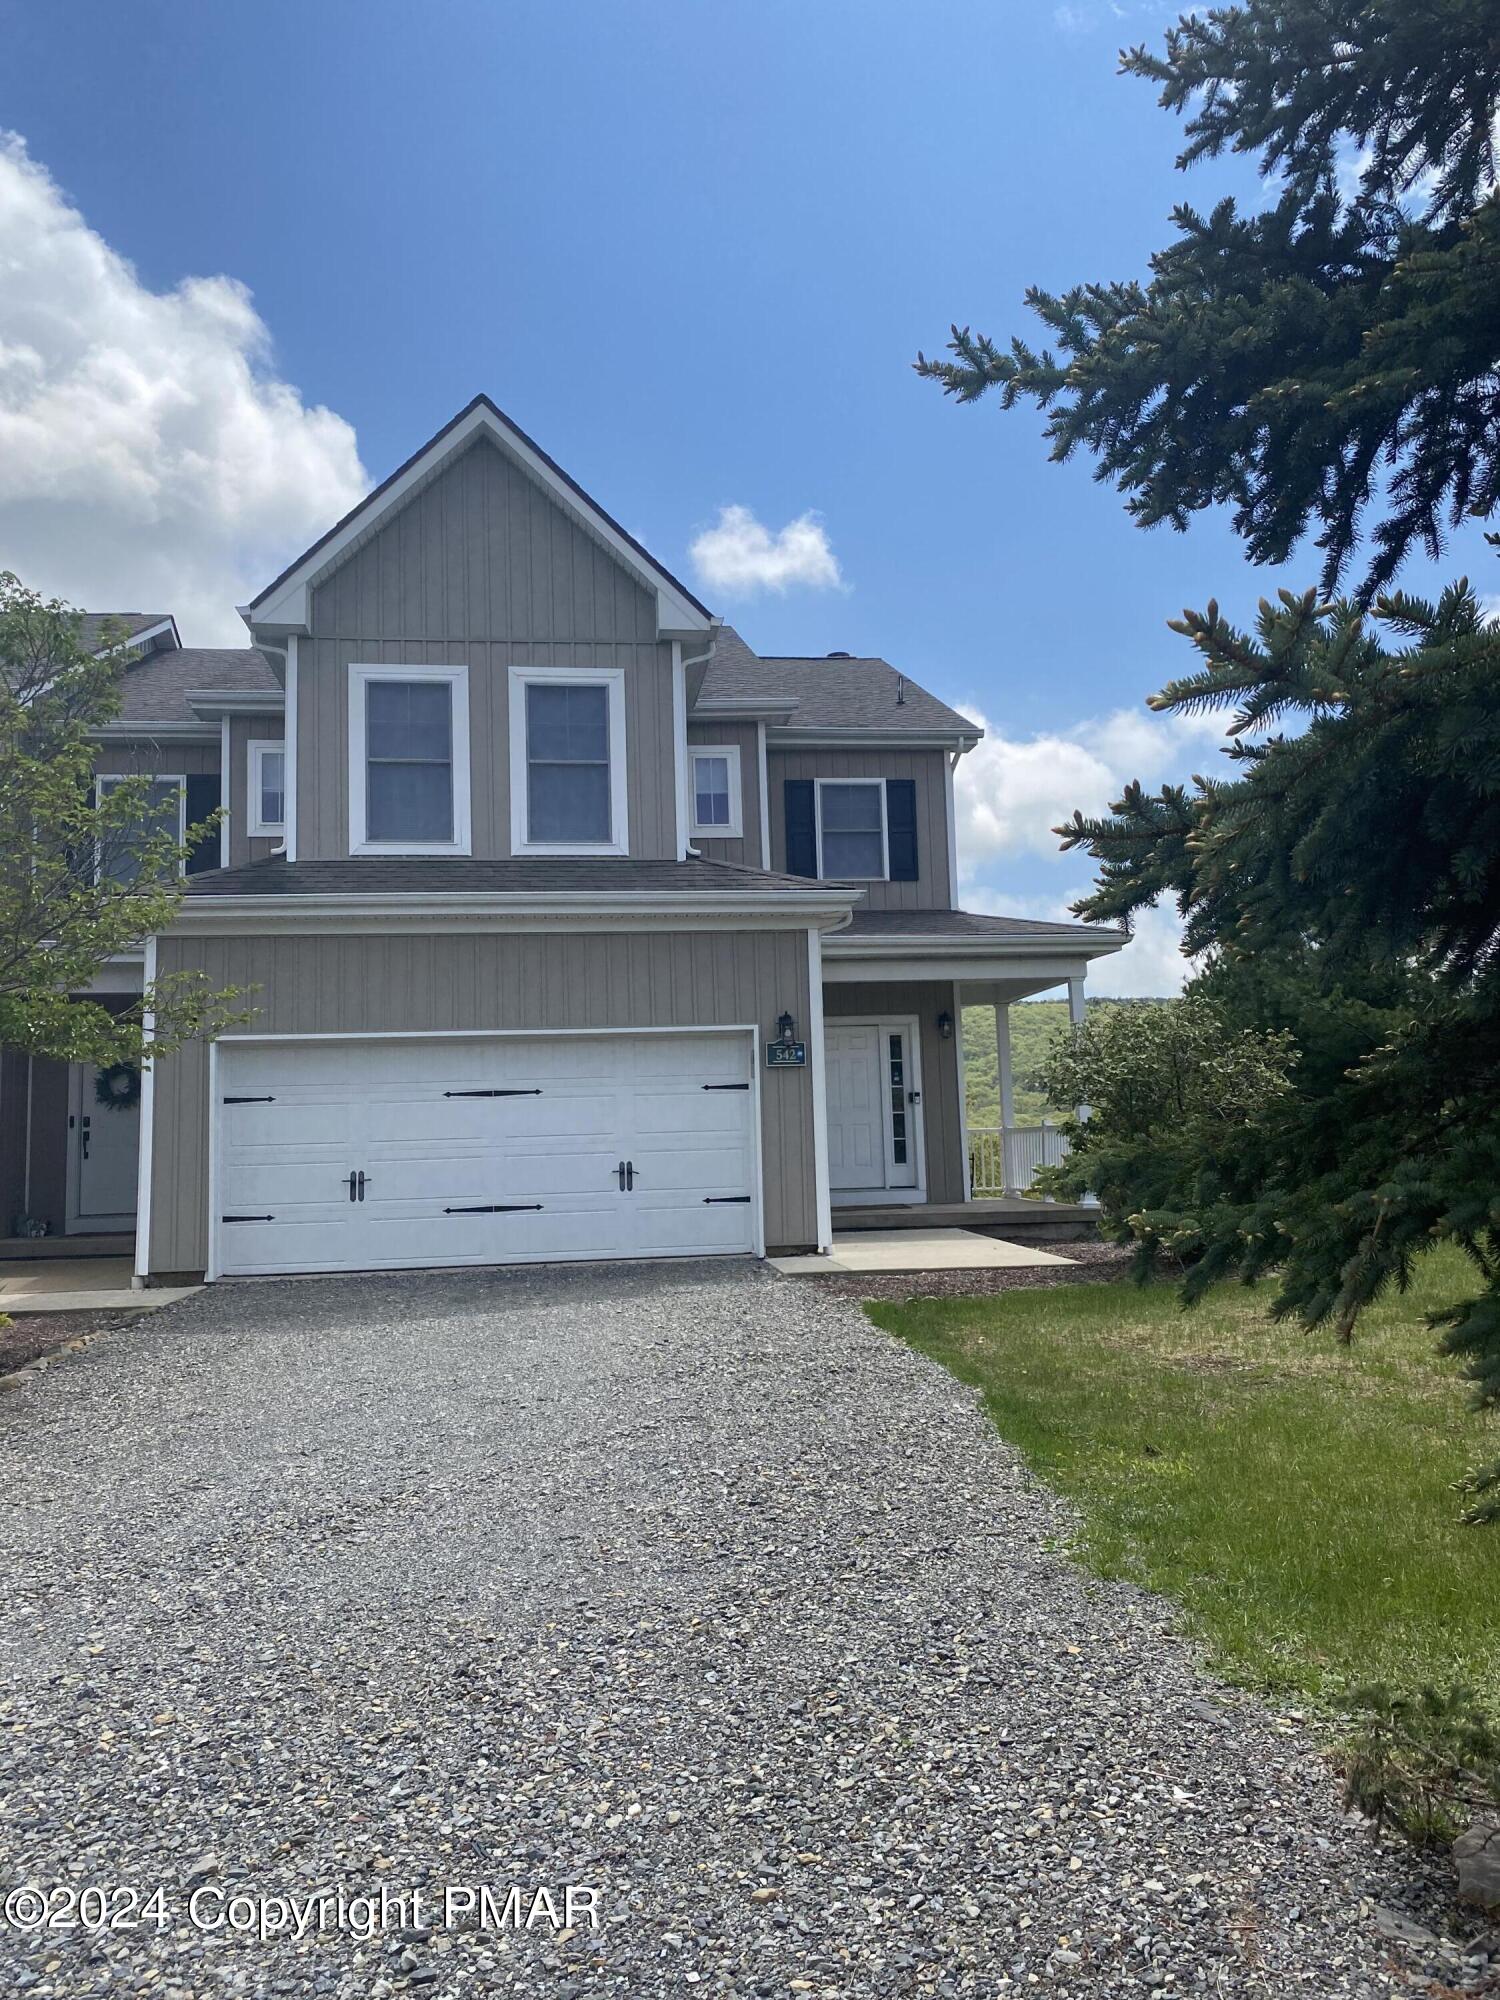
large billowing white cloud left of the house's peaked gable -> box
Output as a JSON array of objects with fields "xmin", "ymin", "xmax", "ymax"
[{"xmin": 0, "ymin": 132, "xmax": 368, "ymax": 646}]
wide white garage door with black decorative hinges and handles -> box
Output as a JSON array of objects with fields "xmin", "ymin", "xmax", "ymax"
[{"xmin": 214, "ymin": 1034, "xmax": 756, "ymax": 1276}]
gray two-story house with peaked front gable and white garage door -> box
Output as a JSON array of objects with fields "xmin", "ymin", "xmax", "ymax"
[{"xmin": 0, "ymin": 398, "xmax": 1124, "ymax": 1282}]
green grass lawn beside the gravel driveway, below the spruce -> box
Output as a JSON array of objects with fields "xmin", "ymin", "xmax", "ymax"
[{"xmin": 868, "ymin": 1252, "xmax": 1500, "ymax": 1706}]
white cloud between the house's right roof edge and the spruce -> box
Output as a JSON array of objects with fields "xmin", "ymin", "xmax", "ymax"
[{"xmin": 954, "ymin": 702, "xmax": 1224, "ymax": 874}]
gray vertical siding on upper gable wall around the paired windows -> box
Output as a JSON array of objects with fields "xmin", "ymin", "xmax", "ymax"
[{"xmin": 298, "ymin": 438, "xmax": 676, "ymax": 860}]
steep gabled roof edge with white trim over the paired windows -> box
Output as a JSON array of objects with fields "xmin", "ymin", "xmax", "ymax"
[{"xmin": 240, "ymin": 396, "xmax": 712, "ymax": 632}]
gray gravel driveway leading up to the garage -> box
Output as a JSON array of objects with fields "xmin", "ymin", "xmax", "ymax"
[{"xmin": 0, "ymin": 1264, "xmax": 1464, "ymax": 2000}]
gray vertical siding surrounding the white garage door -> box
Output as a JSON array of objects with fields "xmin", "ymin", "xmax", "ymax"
[{"xmin": 150, "ymin": 928, "xmax": 818, "ymax": 1272}]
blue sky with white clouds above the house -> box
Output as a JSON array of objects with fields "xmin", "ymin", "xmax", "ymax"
[{"xmin": 0, "ymin": 0, "xmax": 1484, "ymax": 990}]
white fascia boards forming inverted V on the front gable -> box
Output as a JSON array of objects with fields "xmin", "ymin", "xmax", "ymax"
[{"xmin": 240, "ymin": 406, "xmax": 712, "ymax": 638}]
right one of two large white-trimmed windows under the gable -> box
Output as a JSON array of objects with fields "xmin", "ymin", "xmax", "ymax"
[{"xmin": 510, "ymin": 666, "xmax": 630, "ymax": 854}]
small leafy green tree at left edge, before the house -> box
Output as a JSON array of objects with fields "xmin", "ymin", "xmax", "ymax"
[{"xmin": 0, "ymin": 572, "xmax": 246, "ymax": 1066}]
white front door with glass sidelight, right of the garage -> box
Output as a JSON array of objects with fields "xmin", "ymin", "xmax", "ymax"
[{"xmin": 824, "ymin": 1020, "xmax": 922, "ymax": 1200}]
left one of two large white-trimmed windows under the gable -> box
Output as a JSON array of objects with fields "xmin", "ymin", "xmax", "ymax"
[{"xmin": 348, "ymin": 666, "xmax": 470, "ymax": 854}]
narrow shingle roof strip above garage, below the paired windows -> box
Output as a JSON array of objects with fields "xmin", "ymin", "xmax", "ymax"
[{"xmin": 188, "ymin": 854, "xmax": 828, "ymax": 898}]
